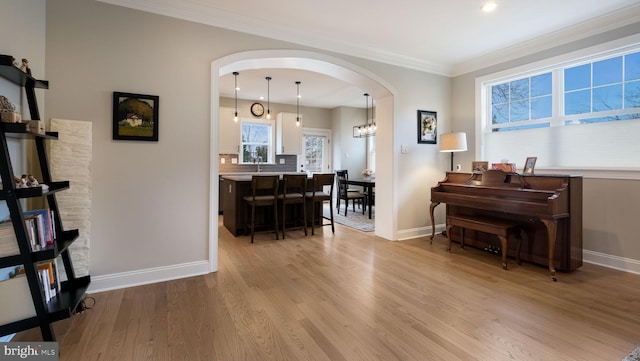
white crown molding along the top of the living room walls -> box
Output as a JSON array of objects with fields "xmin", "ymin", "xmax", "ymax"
[{"xmin": 98, "ymin": 0, "xmax": 640, "ymax": 77}]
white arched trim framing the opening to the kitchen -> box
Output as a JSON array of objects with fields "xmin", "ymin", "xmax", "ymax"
[{"xmin": 209, "ymin": 50, "xmax": 397, "ymax": 272}]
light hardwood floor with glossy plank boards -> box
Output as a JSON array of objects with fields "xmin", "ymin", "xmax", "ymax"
[{"xmin": 12, "ymin": 217, "xmax": 640, "ymax": 361}]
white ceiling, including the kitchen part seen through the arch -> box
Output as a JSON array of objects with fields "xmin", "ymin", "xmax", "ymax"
[{"xmin": 100, "ymin": 0, "xmax": 640, "ymax": 108}]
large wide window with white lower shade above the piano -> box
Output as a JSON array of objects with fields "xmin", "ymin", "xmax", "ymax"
[{"xmin": 476, "ymin": 36, "xmax": 640, "ymax": 171}]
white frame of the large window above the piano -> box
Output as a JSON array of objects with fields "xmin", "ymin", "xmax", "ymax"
[{"xmin": 475, "ymin": 34, "xmax": 640, "ymax": 179}]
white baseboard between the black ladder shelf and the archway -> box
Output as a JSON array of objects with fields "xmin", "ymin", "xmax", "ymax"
[{"xmin": 87, "ymin": 261, "xmax": 209, "ymax": 293}]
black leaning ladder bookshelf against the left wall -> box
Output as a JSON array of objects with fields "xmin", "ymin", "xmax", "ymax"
[{"xmin": 0, "ymin": 62, "xmax": 91, "ymax": 341}]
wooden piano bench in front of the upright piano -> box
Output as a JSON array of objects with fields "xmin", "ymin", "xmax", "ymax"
[{"xmin": 447, "ymin": 214, "xmax": 524, "ymax": 270}]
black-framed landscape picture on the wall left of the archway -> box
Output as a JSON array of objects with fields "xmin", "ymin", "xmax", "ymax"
[{"xmin": 113, "ymin": 92, "xmax": 160, "ymax": 142}]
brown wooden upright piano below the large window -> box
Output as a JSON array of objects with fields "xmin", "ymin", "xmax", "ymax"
[{"xmin": 429, "ymin": 170, "xmax": 582, "ymax": 279}]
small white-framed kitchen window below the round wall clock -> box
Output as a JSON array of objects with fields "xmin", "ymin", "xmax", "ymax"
[{"xmin": 240, "ymin": 120, "xmax": 273, "ymax": 163}]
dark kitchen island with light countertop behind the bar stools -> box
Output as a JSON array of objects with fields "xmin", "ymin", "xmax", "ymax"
[{"xmin": 220, "ymin": 172, "xmax": 322, "ymax": 237}]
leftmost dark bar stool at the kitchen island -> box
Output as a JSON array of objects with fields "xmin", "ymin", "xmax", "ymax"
[{"xmin": 242, "ymin": 175, "xmax": 280, "ymax": 243}]
